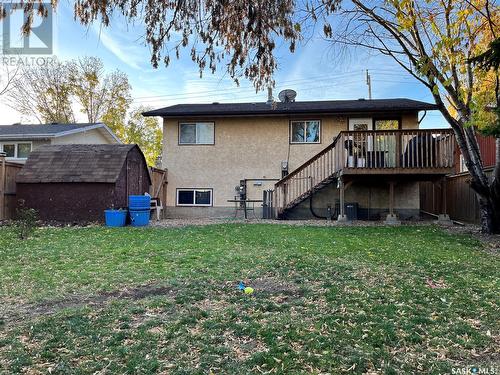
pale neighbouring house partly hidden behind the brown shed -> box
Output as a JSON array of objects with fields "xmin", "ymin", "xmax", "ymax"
[{"xmin": 0, "ymin": 123, "xmax": 121, "ymax": 163}]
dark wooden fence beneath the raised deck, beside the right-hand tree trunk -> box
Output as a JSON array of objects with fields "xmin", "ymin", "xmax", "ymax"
[{"xmin": 420, "ymin": 168, "xmax": 493, "ymax": 224}]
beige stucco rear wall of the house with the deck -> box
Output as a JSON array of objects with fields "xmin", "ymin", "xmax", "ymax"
[{"xmin": 162, "ymin": 113, "xmax": 418, "ymax": 217}]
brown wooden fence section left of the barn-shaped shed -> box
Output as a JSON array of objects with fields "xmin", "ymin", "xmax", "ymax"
[{"xmin": 0, "ymin": 155, "xmax": 23, "ymax": 220}]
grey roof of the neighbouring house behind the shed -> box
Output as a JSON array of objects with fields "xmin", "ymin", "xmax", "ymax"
[{"xmin": 0, "ymin": 123, "xmax": 121, "ymax": 143}]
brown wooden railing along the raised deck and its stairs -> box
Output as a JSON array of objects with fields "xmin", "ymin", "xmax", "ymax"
[{"xmin": 274, "ymin": 129, "xmax": 455, "ymax": 213}]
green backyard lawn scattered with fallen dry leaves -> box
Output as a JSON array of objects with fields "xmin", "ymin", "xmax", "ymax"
[{"xmin": 0, "ymin": 224, "xmax": 500, "ymax": 374}]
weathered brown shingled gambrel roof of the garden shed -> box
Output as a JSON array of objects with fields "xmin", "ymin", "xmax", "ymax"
[{"xmin": 16, "ymin": 144, "xmax": 138, "ymax": 183}]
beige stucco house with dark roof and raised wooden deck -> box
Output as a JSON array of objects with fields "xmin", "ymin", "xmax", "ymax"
[{"xmin": 143, "ymin": 95, "xmax": 455, "ymax": 220}]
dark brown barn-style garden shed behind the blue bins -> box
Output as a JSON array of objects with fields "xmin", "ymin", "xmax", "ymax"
[{"xmin": 16, "ymin": 144, "xmax": 151, "ymax": 222}]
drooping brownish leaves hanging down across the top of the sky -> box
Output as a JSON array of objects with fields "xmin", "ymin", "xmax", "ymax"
[{"xmin": 0, "ymin": 0, "xmax": 308, "ymax": 89}]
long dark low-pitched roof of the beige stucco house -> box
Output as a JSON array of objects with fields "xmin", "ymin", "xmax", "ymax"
[{"xmin": 143, "ymin": 99, "xmax": 437, "ymax": 117}]
